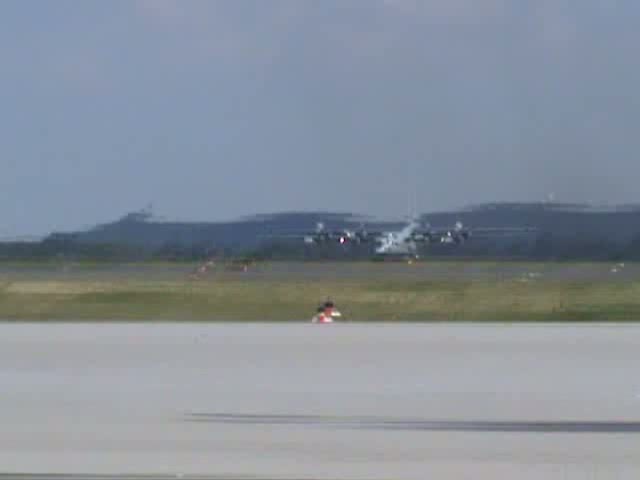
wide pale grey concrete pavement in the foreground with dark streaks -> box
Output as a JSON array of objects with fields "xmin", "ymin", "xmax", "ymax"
[{"xmin": 0, "ymin": 324, "xmax": 640, "ymax": 480}]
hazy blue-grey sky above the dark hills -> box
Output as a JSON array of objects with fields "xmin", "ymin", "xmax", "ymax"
[{"xmin": 0, "ymin": 0, "xmax": 640, "ymax": 235}]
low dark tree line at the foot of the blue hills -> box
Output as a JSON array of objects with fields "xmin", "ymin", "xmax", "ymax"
[{"xmin": 0, "ymin": 232, "xmax": 640, "ymax": 262}]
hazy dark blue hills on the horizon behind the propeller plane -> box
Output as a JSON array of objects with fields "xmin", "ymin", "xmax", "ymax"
[{"xmin": 35, "ymin": 203, "xmax": 640, "ymax": 258}]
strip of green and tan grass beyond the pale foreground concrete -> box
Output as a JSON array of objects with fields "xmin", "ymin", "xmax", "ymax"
[{"xmin": 0, "ymin": 262, "xmax": 640, "ymax": 321}]
